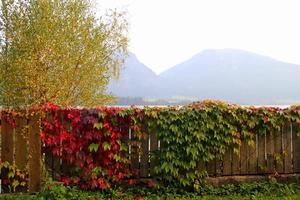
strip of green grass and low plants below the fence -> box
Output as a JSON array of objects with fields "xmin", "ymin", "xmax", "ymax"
[{"xmin": 0, "ymin": 181, "xmax": 300, "ymax": 200}]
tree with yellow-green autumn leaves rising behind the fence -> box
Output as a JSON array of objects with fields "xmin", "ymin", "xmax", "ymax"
[{"xmin": 0, "ymin": 0, "xmax": 128, "ymax": 107}]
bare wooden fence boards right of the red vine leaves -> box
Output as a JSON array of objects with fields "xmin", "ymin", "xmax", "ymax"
[{"xmin": 116, "ymin": 123, "xmax": 300, "ymax": 178}]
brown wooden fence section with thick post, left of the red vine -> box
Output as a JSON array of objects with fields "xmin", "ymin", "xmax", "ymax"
[{"xmin": 1, "ymin": 112, "xmax": 41, "ymax": 193}]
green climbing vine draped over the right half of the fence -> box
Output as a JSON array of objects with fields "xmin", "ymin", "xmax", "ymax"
[{"xmin": 142, "ymin": 101, "xmax": 299, "ymax": 188}]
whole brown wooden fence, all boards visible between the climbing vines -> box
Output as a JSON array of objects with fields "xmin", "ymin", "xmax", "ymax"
[{"xmin": 1, "ymin": 111, "xmax": 300, "ymax": 192}]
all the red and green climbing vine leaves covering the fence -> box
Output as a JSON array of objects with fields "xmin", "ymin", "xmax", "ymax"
[{"xmin": 2, "ymin": 101, "xmax": 300, "ymax": 190}]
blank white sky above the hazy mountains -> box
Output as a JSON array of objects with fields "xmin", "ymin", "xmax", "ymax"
[{"xmin": 96, "ymin": 0, "xmax": 300, "ymax": 73}]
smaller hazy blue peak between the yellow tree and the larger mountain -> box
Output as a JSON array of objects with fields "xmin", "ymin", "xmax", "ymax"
[{"xmin": 108, "ymin": 53, "xmax": 160, "ymax": 97}]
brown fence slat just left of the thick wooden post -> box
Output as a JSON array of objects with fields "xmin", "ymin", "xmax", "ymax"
[{"xmin": 15, "ymin": 116, "xmax": 28, "ymax": 170}]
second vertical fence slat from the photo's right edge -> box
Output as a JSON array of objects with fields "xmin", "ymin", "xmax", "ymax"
[{"xmin": 282, "ymin": 123, "xmax": 293, "ymax": 174}]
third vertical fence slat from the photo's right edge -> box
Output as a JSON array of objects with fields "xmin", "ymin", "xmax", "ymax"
[{"xmin": 274, "ymin": 128, "xmax": 284, "ymax": 174}]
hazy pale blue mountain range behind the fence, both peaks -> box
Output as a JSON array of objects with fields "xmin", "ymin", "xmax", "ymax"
[{"xmin": 108, "ymin": 49, "xmax": 300, "ymax": 104}]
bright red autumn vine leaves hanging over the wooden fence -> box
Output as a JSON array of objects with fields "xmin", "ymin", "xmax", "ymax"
[{"xmin": 41, "ymin": 104, "xmax": 135, "ymax": 190}]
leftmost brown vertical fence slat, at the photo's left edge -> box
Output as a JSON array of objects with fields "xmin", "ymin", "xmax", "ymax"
[{"xmin": 1, "ymin": 112, "xmax": 14, "ymax": 164}]
